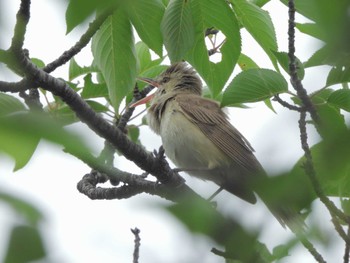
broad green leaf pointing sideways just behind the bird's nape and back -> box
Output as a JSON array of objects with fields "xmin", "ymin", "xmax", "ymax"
[{"xmin": 221, "ymin": 69, "xmax": 288, "ymax": 107}]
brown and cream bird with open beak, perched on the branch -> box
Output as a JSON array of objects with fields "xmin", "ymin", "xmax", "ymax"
[{"xmin": 132, "ymin": 62, "xmax": 304, "ymax": 229}]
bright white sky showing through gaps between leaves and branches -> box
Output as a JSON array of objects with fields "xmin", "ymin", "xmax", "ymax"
[{"xmin": 0, "ymin": 0, "xmax": 343, "ymax": 263}]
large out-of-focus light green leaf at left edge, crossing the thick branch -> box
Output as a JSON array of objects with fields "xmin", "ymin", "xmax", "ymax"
[{"xmin": 0, "ymin": 113, "xmax": 94, "ymax": 170}]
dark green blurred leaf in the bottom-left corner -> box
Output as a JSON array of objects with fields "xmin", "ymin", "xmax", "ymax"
[{"xmin": 4, "ymin": 226, "xmax": 46, "ymax": 263}]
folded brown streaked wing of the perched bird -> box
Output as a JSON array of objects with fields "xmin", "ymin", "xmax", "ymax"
[{"xmin": 175, "ymin": 94, "xmax": 262, "ymax": 172}]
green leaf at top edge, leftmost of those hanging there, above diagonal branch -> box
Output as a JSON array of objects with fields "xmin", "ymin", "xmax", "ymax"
[{"xmin": 66, "ymin": 0, "xmax": 120, "ymax": 34}]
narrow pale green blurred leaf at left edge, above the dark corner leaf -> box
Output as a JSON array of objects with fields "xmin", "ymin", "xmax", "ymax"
[{"xmin": 0, "ymin": 190, "xmax": 43, "ymax": 226}]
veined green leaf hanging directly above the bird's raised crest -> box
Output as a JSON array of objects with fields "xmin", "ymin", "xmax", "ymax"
[{"xmin": 160, "ymin": 0, "xmax": 195, "ymax": 62}]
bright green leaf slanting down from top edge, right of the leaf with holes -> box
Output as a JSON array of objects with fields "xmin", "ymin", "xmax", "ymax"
[{"xmin": 231, "ymin": 0, "xmax": 278, "ymax": 70}]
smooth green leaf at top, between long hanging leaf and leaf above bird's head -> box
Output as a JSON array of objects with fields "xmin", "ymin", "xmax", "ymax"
[{"xmin": 123, "ymin": 0, "xmax": 165, "ymax": 57}]
